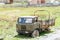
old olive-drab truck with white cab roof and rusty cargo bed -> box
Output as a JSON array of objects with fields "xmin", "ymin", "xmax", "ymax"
[{"xmin": 16, "ymin": 9, "xmax": 55, "ymax": 37}]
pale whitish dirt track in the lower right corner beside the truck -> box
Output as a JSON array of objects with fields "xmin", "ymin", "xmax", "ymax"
[{"xmin": 33, "ymin": 27, "xmax": 60, "ymax": 40}]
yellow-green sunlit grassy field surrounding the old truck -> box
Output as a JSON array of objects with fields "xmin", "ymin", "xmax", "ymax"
[{"xmin": 0, "ymin": 7, "xmax": 60, "ymax": 40}]
